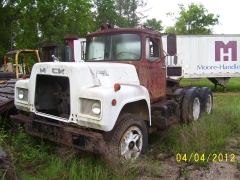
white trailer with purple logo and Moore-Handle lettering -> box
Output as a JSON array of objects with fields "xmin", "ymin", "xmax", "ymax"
[{"xmin": 163, "ymin": 34, "xmax": 240, "ymax": 91}]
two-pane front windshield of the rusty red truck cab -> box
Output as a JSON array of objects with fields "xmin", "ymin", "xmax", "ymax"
[{"xmin": 85, "ymin": 34, "xmax": 141, "ymax": 61}]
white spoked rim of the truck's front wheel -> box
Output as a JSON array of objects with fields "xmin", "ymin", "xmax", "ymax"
[{"xmin": 120, "ymin": 126, "xmax": 143, "ymax": 159}]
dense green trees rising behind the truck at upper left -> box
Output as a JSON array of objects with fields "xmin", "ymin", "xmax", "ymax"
[{"xmin": 0, "ymin": 0, "xmax": 150, "ymax": 62}]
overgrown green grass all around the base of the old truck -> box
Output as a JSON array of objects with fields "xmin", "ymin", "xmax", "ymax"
[{"xmin": 0, "ymin": 78, "xmax": 240, "ymax": 180}]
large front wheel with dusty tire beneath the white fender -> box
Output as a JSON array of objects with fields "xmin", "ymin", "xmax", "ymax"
[{"xmin": 104, "ymin": 114, "xmax": 148, "ymax": 159}]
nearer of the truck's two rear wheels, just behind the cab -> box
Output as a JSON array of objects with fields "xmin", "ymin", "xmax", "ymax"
[{"xmin": 182, "ymin": 89, "xmax": 201, "ymax": 123}]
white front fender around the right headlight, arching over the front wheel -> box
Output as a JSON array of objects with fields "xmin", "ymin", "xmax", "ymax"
[{"xmin": 76, "ymin": 84, "xmax": 151, "ymax": 131}]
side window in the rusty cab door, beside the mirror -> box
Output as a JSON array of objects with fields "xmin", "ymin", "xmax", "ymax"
[{"xmin": 146, "ymin": 37, "xmax": 160, "ymax": 61}]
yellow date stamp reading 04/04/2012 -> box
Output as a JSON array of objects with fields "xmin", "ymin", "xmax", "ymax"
[{"xmin": 176, "ymin": 153, "xmax": 235, "ymax": 163}]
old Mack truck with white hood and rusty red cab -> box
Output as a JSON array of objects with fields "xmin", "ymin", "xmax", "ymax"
[{"xmin": 11, "ymin": 24, "xmax": 213, "ymax": 159}]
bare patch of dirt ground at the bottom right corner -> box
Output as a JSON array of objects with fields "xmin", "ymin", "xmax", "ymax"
[{"xmin": 139, "ymin": 138, "xmax": 240, "ymax": 180}]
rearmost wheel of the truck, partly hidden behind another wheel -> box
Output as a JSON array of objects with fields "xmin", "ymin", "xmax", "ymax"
[{"xmin": 200, "ymin": 87, "xmax": 213, "ymax": 114}]
